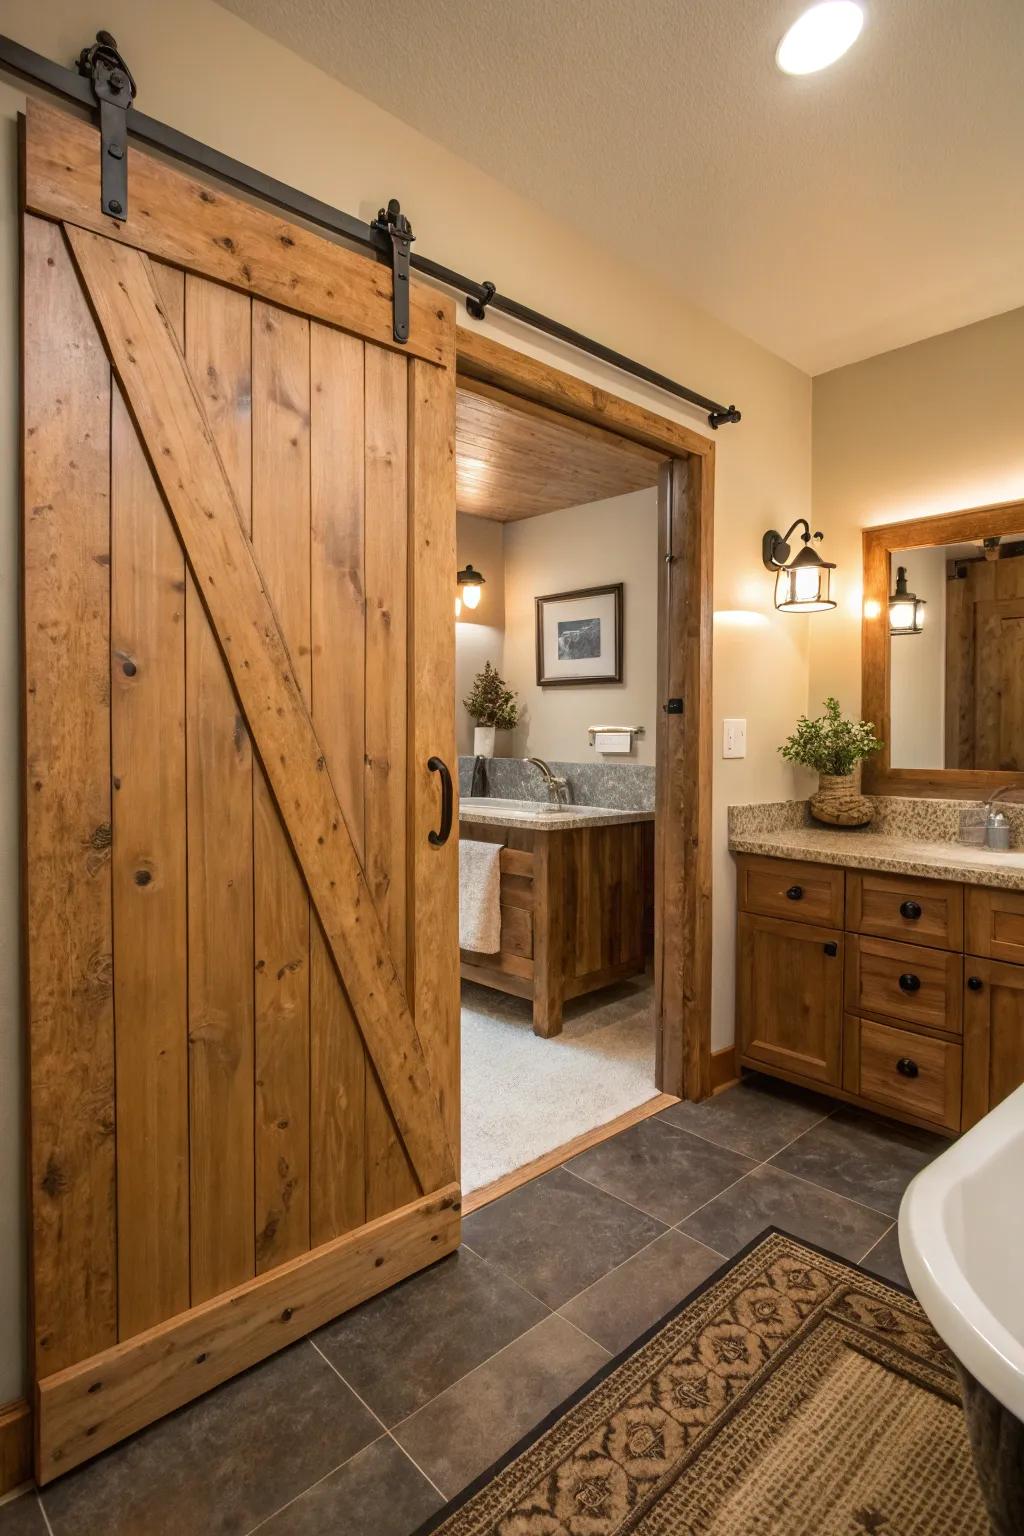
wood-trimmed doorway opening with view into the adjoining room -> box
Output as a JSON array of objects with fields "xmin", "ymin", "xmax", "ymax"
[{"xmin": 453, "ymin": 332, "xmax": 712, "ymax": 1209}]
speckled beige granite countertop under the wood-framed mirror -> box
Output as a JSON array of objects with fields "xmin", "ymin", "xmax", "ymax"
[{"xmin": 729, "ymin": 806, "xmax": 1024, "ymax": 891}]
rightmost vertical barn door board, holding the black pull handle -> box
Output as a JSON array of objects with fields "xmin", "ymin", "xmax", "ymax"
[{"xmin": 408, "ymin": 361, "xmax": 461, "ymax": 1167}]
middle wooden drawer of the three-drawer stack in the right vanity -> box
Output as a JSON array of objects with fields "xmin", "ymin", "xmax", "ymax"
[{"xmin": 846, "ymin": 934, "xmax": 964, "ymax": 1035}]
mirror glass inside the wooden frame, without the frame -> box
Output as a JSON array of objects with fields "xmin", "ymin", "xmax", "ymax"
[{"xmin": 889, "ymin": 535, "xmax": 1024, "ymax": 773}]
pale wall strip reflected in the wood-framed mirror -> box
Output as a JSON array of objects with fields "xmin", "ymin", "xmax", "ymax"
[{"xmin": 889, "ymin": 548, "xmax": 946, "ymax": 768}]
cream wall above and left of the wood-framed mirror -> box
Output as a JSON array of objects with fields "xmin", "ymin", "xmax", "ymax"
[{"xmin": 808, "ymin": 309, "xmax": 1024, "ymax": 724}]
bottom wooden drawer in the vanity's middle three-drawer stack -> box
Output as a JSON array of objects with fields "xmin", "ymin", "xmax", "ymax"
[{"xmin": 843, "ymin": 1015, "xmax": 963, "ymax": 1130}]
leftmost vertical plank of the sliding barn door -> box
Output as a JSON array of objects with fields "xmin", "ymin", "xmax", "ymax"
[{"xmin": 23, "ymin": 217, "xmax": 117, "ymax": 1376}]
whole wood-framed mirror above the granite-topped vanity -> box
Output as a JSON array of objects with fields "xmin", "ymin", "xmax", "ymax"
[{"xmin": 861, "ymin": 501, "xmax": 1024, "ymax": 799}]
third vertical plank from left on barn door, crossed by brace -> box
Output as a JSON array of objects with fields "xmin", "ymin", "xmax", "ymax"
[{"xmin": 186, "ymin": 275, "xmax": 255, "ymax": 1306}]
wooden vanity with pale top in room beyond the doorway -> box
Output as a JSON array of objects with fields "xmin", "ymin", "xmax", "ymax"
[{"xmin": 459, "ymin": 797, "xmax": 654, "ymax": 1037}]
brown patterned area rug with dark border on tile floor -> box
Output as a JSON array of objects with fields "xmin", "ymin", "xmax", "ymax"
[{"xmin": 421, "ymin": 1232, "xmax": 989, "ymax": 1536}]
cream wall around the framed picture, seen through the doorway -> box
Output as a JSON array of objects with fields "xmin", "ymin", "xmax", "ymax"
[{"xmin": 505, "ymin": 490, "xmax": 657, "ymax": 763}]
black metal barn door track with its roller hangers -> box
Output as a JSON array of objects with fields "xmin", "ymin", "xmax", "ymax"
[{"xmin": 0, "ymin": 32, "xmax": 740, "ymax": 430}]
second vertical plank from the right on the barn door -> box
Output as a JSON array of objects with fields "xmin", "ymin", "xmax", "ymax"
[{"xmin": 364, "ymin": 346, "xmax": 419, "ymax": 1218}]
